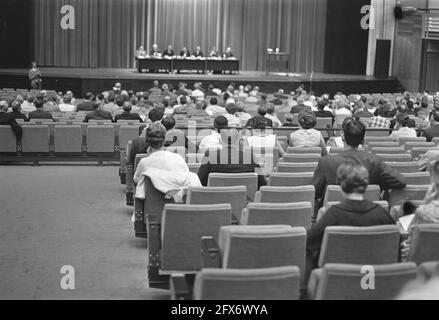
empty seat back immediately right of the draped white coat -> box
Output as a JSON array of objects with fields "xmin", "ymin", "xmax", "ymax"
[{"xmin": 186, "ymin": 185, "xmax": 247, "ymax": 223}]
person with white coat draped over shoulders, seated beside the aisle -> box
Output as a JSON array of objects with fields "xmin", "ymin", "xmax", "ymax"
[{"xmin": 133, "ymin": 122, "xmax": 201, "ymax": 202}]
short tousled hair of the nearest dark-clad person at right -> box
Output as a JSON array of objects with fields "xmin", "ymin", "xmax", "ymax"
[{"xmin": 337, "ymin": 163, "xmax": 369, "ymax": 194}]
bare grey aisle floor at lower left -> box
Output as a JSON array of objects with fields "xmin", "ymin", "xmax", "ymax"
[{"xmin": 0, "ymin": 166, "xmax": 169, "ymax": 299}]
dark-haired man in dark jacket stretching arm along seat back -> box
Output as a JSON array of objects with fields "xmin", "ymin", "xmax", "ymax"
[{"xmin": 312, "ymin": 117, "xmax": 406, "ymax": 205}]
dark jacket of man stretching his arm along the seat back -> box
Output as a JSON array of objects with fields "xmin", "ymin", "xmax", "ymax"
[{"xmin": 312, "ymin": 150, "xmax": 406, "ymax": 199}]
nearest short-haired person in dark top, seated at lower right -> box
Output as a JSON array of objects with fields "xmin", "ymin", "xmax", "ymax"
[{"xmin": 306, "ymin": 163, "xmax": 395, "ymax": 266}]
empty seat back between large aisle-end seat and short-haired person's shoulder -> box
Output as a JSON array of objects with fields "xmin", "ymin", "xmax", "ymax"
[{"xmin": 241, "ymin": 202, "xmax": 313, "ymax": 230}]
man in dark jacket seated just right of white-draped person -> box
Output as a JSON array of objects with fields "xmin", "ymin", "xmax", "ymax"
[{"xmin": 198, "ymin": 128, "xmax": 266, "ymax": 188}]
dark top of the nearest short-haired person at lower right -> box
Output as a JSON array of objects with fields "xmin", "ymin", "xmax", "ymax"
[{"xmin": 306, "ymin": 200, "xmax": 395, "ymax": 251}]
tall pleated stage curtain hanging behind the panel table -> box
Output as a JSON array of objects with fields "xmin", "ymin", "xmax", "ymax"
[{"xmin": 34, "ymin": 0, "xmax": 327, "ymax": 72}]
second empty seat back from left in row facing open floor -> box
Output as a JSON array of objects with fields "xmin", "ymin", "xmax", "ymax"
[{"xmin": 22, "ymin": 124, "xmax": 49, "ymax": 153}]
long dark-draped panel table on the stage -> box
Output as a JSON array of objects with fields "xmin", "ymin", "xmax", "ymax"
[{"xmin": 136, "ymin": 57, "xmax": 239, "ymax": 73}]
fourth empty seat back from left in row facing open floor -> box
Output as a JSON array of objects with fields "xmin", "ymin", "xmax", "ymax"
[{"xmin": 87, "ymin": 124, "xmax": 114, "ymax": 153}]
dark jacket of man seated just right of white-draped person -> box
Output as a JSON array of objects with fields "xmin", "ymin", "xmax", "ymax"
[{"xmin": 198, "ymin": 146, "xmax": 266, "ymax": 188}]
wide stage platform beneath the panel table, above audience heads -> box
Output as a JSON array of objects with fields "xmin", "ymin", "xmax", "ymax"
[{"xmin": 0, "ymin": 67, "xmax": 403, "ymax": 95}]
